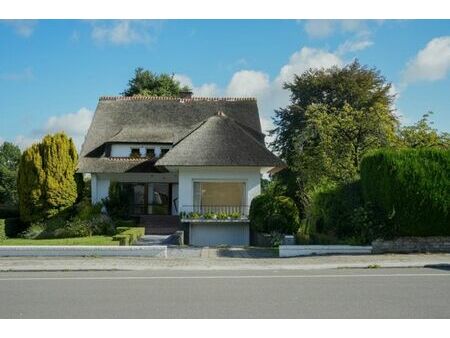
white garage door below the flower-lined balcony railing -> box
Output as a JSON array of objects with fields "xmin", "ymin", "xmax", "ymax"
[{"xmin": 189, "ymin": 223, "xmax": 250, "ymax": 246}]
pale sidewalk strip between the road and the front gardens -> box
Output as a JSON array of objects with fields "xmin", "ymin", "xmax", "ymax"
[{"xmin": 0, "ymin": 248, "xmax": 450, "ymax": 271}]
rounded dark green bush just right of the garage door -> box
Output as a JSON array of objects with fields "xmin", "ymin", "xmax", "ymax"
[{"xmin": 249, "ymin": 194, "xmax": 299, "ymax": 234}]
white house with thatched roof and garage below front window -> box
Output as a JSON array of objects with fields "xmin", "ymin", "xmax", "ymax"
[{"xmin": 78, "ymin": 93, "xmax": 284, "ymax": 245}]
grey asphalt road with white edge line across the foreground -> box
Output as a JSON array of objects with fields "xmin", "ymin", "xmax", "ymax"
[{"xmin": 0, "ymin": 269, "xmax": 450, "ymax": 318}]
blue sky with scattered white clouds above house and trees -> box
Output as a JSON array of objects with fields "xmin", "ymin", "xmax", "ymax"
[{"xmin": 0, "ymin": 20, "xmax": 450, "ymax": 147}]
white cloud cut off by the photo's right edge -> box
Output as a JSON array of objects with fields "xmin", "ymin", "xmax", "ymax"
[{"xmin": 403, "ymin": 36, "xmax": 450, "ymax": 85}]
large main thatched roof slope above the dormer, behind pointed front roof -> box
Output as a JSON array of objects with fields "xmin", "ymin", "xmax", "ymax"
[{"xmin": 81, "ymin": 96, "xmax": 264, "ymax": 157}]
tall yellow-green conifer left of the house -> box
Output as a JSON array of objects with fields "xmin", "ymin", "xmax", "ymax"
[{"xmin": 18, "ymin": 133, "xmax": 78, "ymax": 222}]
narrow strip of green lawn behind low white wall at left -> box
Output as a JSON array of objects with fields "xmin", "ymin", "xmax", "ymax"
[{"xmin": 0, "ymin": 236, "xmax": 119, "ymax": 245}]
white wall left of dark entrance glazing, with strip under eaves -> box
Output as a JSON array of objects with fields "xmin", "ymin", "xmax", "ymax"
[{"xmin": 91, "ymin": 173, "xmax": 178, "ymax": 203}]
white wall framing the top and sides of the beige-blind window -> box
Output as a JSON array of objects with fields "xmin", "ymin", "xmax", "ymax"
[{"xmin": 178, "ymin": 167, "xmax": 261, "ymax": 215}]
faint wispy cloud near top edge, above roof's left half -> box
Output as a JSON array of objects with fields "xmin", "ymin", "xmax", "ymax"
[{"xmin": 91, "ymin": 20, "xmax": 158, "ymax": 45}]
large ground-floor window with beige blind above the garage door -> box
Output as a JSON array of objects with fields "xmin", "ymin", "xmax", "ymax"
[{"xmin": 194, "ymin": 182, "xmax": 246, "ymax": 213}]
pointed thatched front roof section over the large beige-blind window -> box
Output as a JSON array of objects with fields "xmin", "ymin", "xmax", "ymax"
[{"xmin": 156, "ymin": 112, "xmax": 285, "ymax": 167}]
